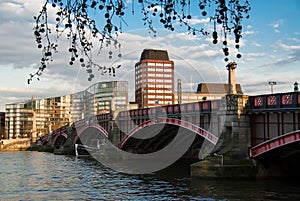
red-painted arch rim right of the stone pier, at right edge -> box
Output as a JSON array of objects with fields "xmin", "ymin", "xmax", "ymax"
[{"xmin": 250, "ymin": 130, "xmax": 300, "ymax": 158}]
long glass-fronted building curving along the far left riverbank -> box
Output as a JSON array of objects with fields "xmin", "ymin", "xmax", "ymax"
[{"xmin": 4, "ymin": 81, "xmax": 128, "ymax": 139}]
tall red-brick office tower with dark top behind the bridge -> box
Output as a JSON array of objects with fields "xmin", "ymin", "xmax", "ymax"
[{"xmin": 135, "ymin": 49, "xmax": 174, "ymax": 108}]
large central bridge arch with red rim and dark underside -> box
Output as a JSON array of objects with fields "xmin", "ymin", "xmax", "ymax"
[{"xmin": 119, "ymin": 118, "xmax": 218, "ymax": 163}]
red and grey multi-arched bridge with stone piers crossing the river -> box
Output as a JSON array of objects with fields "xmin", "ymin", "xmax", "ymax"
[{"xmin": 38, "ymin": 92, "xmax": 300, "ymax": 177}]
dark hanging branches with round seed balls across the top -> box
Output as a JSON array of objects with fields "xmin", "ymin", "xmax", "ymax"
[{"xmin": 28, "ymin": 0, "xmax": 250, "ymax": 83}]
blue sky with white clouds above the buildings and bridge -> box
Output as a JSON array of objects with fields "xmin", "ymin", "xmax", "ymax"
[{"xmin": 0, "ymin": 0, "xmax": 300, "ymax": 111}]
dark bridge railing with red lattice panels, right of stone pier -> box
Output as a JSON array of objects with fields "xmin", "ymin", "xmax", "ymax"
[{"xmin": 249, "ymin": 92, "xmax": 300, "ymax": 110}]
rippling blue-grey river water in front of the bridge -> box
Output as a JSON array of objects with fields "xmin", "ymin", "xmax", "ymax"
[{"xmin": 0, "ymin": 151, "xmax": 300, "ymax": 201}]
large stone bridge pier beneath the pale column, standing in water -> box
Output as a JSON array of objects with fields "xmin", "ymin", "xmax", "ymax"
[{"xmin": 191, "ymin": 94, "xmax": 255, "ymax": 178}]
